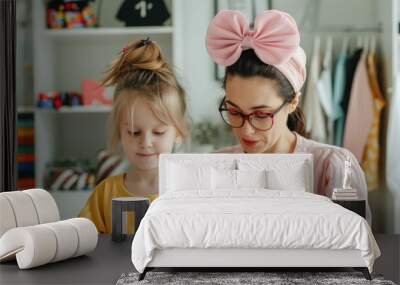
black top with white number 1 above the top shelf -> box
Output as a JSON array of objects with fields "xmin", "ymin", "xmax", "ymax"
[{"xmin": 116, "ymin": 0, "xmax": 170, "ymax": 27}]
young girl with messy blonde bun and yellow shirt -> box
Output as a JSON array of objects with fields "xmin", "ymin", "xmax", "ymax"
[{"xmin": 79, "ymin": 39, "xmax": 188, "ymax": 234}]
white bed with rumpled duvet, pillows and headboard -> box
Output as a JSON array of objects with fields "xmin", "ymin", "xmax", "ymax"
[{"xmin": 132, "ymin": 154, "xmax": 380, "ymax": 279}]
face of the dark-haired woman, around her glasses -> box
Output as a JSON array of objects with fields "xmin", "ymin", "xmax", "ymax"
[{"xmin": 226, "ymin": 76, "xmax": 290, "ymax": 153}]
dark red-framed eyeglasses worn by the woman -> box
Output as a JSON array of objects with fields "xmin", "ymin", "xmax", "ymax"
[{"xmin": 218, "ymin": 98, "xmax": 288, "ymax": 131}]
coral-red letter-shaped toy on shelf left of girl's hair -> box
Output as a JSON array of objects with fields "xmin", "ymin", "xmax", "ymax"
[{"xmin": 82, "ymin": 80, "xmax": 112, "ymax": 106}]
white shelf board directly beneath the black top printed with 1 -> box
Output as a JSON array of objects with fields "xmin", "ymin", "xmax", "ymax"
[{"xmin": 43, "ymin": 26, "xmax": 173, "ymax": 38}]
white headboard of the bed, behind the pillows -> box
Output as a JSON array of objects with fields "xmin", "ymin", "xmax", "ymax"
[{"xmin": 159, "ymin": 153, "xmax": 314, "ymax": 195}]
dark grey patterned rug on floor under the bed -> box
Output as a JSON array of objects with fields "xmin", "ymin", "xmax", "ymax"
[{"xmin": 117, "ymin": 271, "xmax": 395, "ymax": 285}]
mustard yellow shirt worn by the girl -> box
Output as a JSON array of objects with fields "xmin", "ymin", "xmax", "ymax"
[{"xmin": 79, "ymin": 174, "xmax": 158, "ymax": 234}]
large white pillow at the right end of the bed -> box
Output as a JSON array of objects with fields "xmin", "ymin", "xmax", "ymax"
[{"xmin": 267, "ymin": 163, "xmax": 308, "ymax": 192}]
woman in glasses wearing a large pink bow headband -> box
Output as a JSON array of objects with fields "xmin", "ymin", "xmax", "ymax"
[{"xmin": 206, "ymin": 10, "xmax": 370, "ymax": 221}]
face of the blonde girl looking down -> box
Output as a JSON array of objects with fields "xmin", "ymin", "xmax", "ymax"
[{"xmin": 120, "ymin": 97, "xmax": 179, "ymax": 170}]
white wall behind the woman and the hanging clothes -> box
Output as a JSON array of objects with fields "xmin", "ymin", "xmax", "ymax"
[{"xmin": 181, "ymin": 0, "xmax": 400, "ymax": 233}]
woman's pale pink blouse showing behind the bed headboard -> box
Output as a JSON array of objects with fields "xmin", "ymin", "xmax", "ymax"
[{"xmin": 217, "ymin": 133, "xmax": 371, "ymax": 223}]
